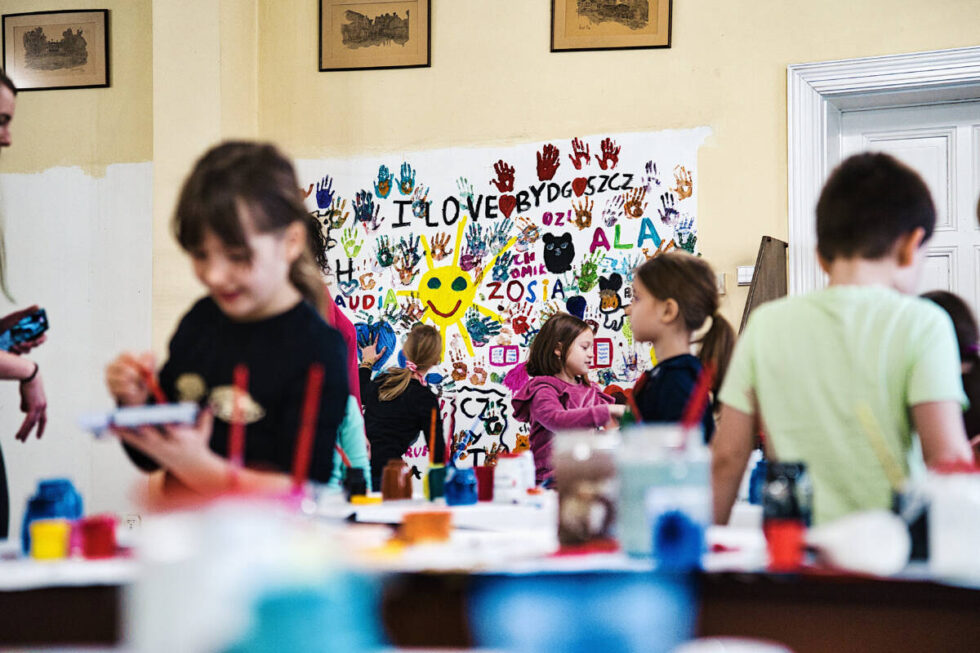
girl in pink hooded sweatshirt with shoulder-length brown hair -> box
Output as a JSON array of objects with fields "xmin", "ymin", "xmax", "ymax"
[{"xmin": 511, "ymin": 313, "xmax": 625, "ymax": 485}]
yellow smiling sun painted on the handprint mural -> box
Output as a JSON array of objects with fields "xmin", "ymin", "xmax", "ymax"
[{"xmin": 398, "ymin": 215, "xmax": 517, "ymax": 357}]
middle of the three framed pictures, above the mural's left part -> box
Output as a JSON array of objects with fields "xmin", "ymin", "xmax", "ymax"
[{"xmin": 319, "ymin": 0, "xmax": 431, "ymax": 71}]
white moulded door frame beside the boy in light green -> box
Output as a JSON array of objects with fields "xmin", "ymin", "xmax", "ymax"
[{"xmin": 786, "ymin": 47, "xmax": 980, "ymax": 294}]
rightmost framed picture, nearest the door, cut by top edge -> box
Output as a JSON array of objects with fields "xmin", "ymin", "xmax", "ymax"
[{"xmin": 551, "ymin": 0, "xmax": 671, "ymax": 52}]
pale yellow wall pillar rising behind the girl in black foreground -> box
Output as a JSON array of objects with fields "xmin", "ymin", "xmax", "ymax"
[{"xmin": 152, "ymin": 0, "xmax": 258, "ymax": 356}]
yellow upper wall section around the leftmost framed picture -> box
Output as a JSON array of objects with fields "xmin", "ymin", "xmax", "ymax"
[{"xmin": 0, "ymin": 0, "xmax": 153, "ymax": 176}]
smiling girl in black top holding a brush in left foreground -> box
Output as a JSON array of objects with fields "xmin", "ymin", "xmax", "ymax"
[{"xmin": 106, "ymin": 142, "xmax": 350, "ymax": 494}]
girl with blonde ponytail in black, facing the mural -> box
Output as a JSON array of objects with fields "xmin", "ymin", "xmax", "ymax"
[{"xmin": 359, "ymin": 324, "xmax": 445, "ymax": 488}]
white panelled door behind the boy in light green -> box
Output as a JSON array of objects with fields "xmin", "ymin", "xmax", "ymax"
[{"xmin": 841, "ymin": 102, "xmax": 980, "ymax": 315}]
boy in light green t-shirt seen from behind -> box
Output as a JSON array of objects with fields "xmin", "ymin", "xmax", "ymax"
[{"xmin": 712, "ymin": 154, "xmax": 973, "ymax": 524}]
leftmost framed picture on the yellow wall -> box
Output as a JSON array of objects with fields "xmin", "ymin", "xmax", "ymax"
[{"xmin": 3, "ymin": 9, "xmax": 109, "ymax": 91}]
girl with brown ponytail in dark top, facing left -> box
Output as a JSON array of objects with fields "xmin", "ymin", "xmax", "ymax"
[{"xmin": 627, "ymin": 252, "xmax": 735, "ymax": 442}]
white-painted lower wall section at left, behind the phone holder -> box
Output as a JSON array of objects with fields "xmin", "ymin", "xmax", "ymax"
[{"xmin": 0, "ymin": 163, "xmax": 153, "ymax": 528}]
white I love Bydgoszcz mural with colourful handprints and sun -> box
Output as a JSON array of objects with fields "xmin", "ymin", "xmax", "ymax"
[{"xmin": 297, "ymin": 128, "xmax": 710, "ymax": 454}]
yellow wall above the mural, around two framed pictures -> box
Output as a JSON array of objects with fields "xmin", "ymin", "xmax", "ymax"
[{"xmin": 258, "ymin": 0, "xmax": 980, "ymax": 324}]
